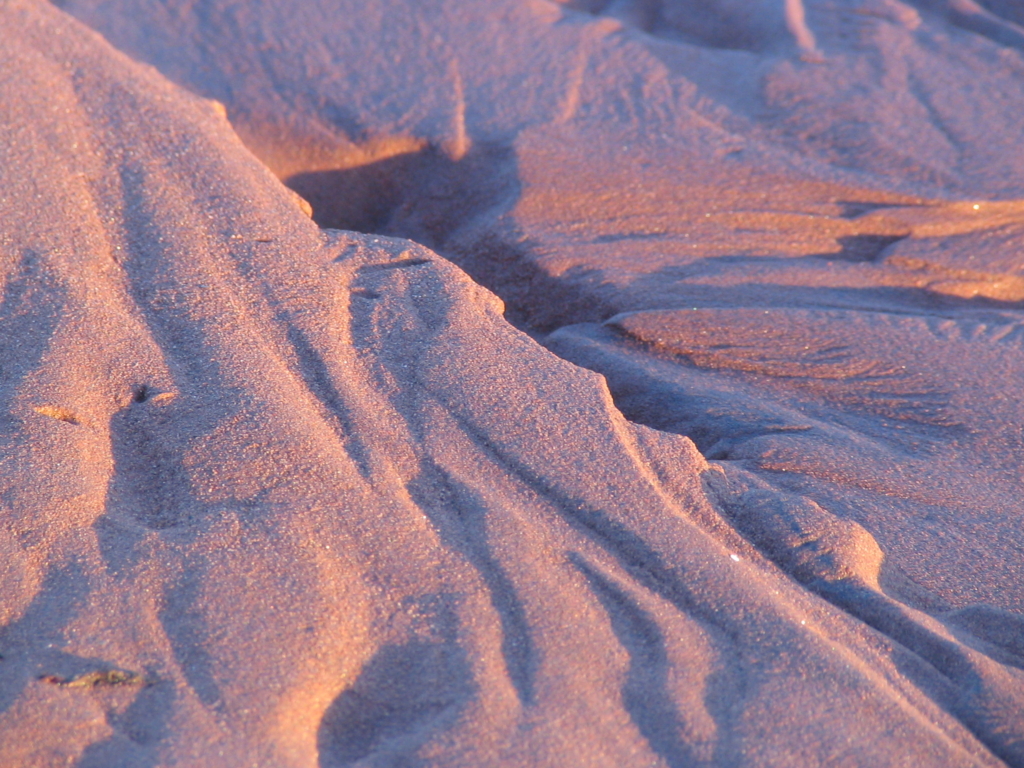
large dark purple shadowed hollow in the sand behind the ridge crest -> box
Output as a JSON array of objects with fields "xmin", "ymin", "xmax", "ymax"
[{"xmin": 285, "ymin": 144, "xmax": 614, "ymax": 332}]
